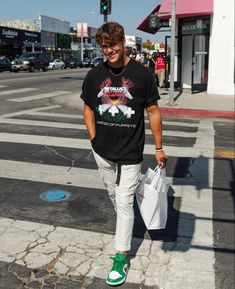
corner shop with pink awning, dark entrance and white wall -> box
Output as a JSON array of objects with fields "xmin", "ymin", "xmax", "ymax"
[{"xmin": 137, "ymin": 0, "xmax": 234, "ymax": 95}]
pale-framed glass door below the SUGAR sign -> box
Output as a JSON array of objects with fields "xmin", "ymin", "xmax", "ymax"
[{"xmin": 191, "ymin": 34, "xmax": 209, "ymax": 93}]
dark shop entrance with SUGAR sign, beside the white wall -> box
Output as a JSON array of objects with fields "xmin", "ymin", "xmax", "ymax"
[{"xmin": 165, "ymin": 16, "xmax": 210, "ymax": 93}]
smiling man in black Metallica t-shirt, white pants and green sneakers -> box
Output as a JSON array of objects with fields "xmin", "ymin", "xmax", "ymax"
[{"xmin": 81, "ymin": 22, "xmax": 167, "ymax": 286}]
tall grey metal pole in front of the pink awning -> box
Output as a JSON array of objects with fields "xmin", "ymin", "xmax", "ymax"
[{"xmin": 169, "ymin": 0, "xmax": 176, "ymax": 105}]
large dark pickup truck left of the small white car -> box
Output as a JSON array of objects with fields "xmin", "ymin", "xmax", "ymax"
[{"xmin": 11, "ymin": 52, "xmax": 49, "ymax": 72}]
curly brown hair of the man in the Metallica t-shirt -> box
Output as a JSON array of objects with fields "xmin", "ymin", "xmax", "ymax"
[{"xmin": 95, "ymin": 22, "xmax": 125, "ymax": 45}]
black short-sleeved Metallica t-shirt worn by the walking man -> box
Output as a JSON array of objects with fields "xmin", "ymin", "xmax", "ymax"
[{"xmin": 81, "ymin": 60, "xmax": 160, "ymax": 164}]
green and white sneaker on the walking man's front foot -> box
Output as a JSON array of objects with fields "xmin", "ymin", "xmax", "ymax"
[{"xmin": 106, "ymin": 253, "xmax": 128, "ymax": 286}]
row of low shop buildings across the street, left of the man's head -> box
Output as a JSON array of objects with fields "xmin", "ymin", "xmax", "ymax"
[{"xmin": 0, "ymin": 15, "xmax": 101, "ymax": 61}]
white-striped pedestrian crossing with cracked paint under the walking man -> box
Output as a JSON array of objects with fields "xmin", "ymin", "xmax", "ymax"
[{"xmin": 0, "ymin": 84, "xmax": 216, "ymax": 288}]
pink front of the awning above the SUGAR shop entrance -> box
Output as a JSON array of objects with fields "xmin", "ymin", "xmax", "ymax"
[{"xmin": 159, "ymin": 0, "xmax": 214, "ymax": 19}]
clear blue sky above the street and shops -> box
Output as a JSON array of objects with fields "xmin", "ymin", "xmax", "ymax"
[{"xmin": 0, "ymin": 0, "xmax": 169, "ymax": 42}]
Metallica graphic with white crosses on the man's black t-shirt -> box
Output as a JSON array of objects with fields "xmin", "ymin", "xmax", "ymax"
[{"xmin": 97, "ymin": 77, "xmax": 135, "ymax": 121}]
